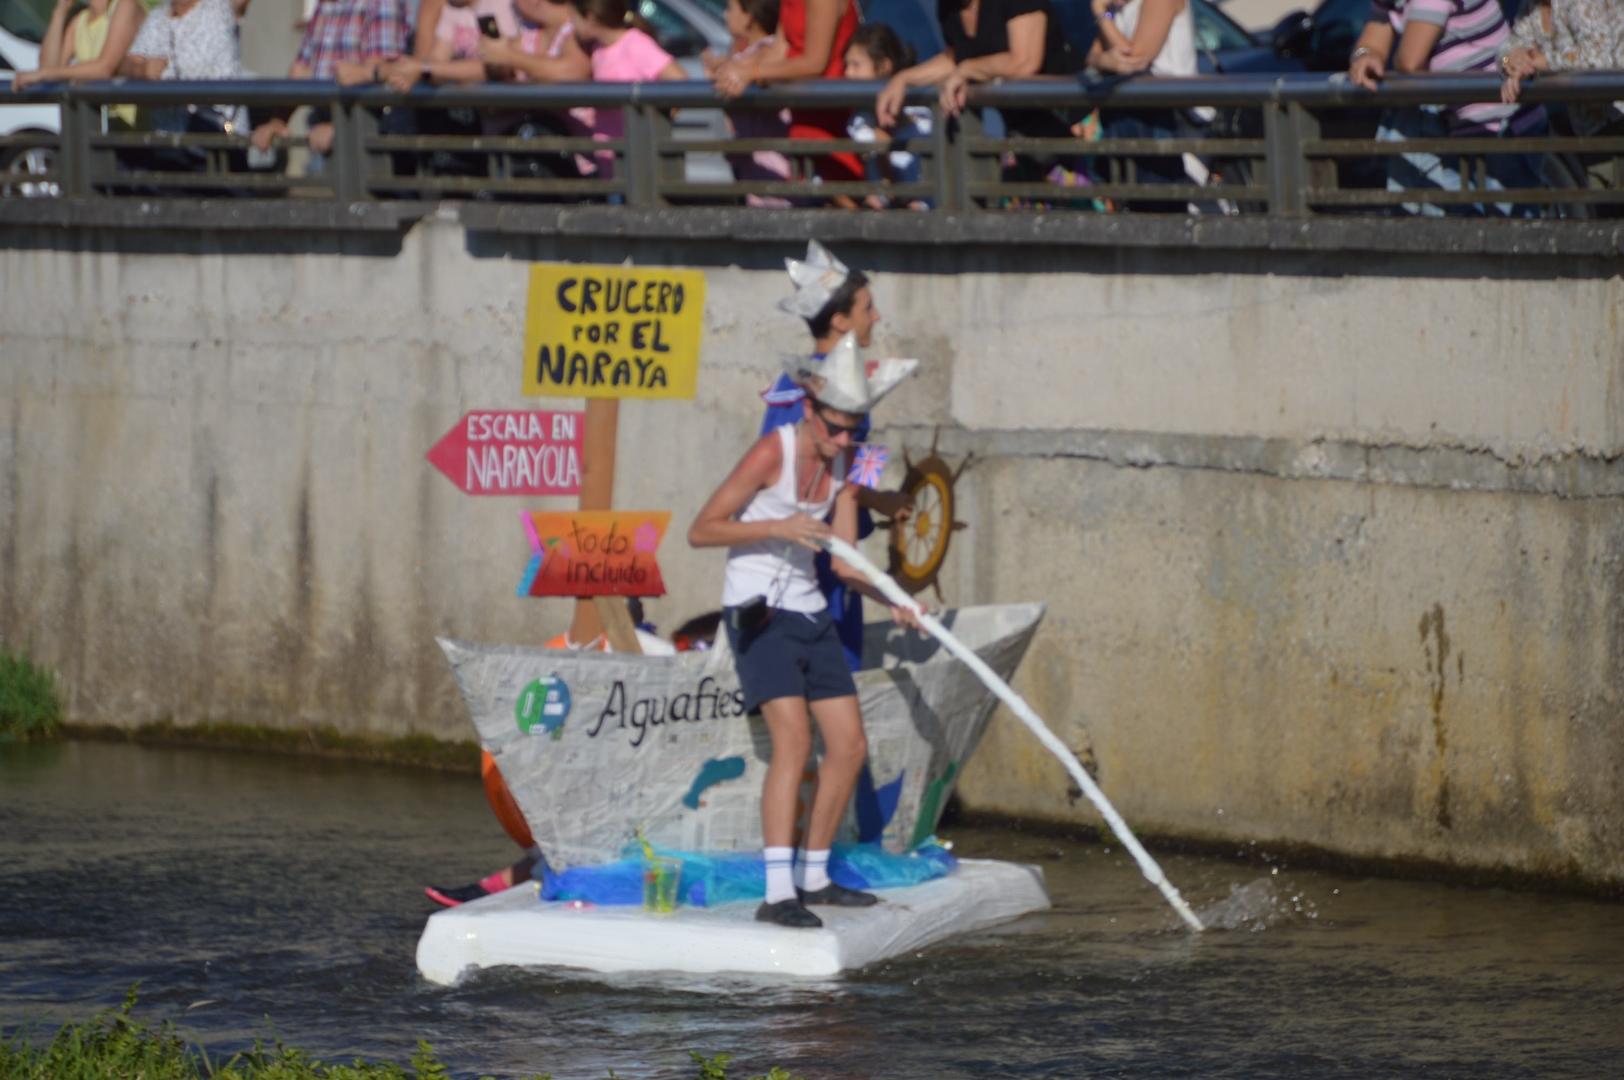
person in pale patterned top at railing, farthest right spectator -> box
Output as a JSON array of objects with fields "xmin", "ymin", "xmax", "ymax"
[{"xmin": 1501, "ymin": 0, "xmax": 1624, "ymax": 204}]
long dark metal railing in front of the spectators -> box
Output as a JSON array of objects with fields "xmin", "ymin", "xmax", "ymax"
[{"xmin": 0, "ymin": 71, "xmax": 1624, "ymax": 218}]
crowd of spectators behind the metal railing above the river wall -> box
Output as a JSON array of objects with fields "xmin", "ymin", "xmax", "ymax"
[{"xmin": 15, "ymin": 0, "xmax": 1624, "ymax": 216}]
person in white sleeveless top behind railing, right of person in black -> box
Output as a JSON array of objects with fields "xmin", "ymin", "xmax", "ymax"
[{"xmin": 1088, "ymin": 0, "xmax": 1216, "ymax": 210}]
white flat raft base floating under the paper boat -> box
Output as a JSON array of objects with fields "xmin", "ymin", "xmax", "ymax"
[{"xmin": 417, "ymin": 859, "xmax": 1049, "ymax": 986}]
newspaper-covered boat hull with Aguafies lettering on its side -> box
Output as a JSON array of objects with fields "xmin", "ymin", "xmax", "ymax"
[{"xmin": 440, "ymin": 604, "xmax": 1044, "ymax": 869}]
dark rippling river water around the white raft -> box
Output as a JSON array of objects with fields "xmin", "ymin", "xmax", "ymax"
[{"xmin": 0, "ymin": 742, "xmax": 1624, "ymax": 1080}]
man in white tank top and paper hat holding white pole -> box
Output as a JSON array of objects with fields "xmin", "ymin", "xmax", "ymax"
[{"xmin": 689, "ymin": 284, "xmax": 918, "ymax": 927}]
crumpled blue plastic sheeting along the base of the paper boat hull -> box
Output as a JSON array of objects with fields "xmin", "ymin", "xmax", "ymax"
[{"xmin": 541, "ymin": 838, "xmax": 958, "ymax": 908}]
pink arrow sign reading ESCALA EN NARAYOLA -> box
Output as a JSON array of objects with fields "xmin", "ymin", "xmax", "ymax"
[{"xmin": 424, "ymin": 409, "xmax": 583, "ymax": 495}]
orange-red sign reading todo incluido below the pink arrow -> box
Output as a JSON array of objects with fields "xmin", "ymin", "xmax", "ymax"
[{"xmin": 518, "ymin": 510, "xmax": 671, "ymax": 596}]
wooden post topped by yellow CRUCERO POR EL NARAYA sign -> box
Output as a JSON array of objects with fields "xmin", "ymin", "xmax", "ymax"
[{"xmin": 523, "ymin": 263, "xmax": 705, "ymax": 653}]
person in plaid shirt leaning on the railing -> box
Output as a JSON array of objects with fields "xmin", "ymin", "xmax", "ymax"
[{"xmin": 252, "ymin": 0, "xmax": 417, "ymax": 174}]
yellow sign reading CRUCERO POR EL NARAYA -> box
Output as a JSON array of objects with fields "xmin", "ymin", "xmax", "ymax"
[{"xmin": 525, "ymin": 263, "xmax": 705, "ymax": 398}]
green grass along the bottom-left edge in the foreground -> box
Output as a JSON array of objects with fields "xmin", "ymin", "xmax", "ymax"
[{"xmin": 0, "ymin": 987, "xmax": 794, "ymax": 1080}]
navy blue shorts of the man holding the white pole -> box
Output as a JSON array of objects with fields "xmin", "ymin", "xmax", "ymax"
[{"xmin": 723, "ymin": 607, "xmax": 857, "ymax": 713}]
